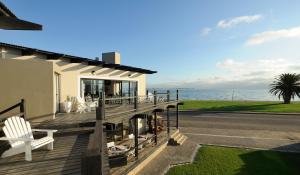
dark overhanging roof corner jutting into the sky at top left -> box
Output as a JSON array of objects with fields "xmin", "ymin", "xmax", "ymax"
[{"xmin": 0, "ymin": 1, "xmax": 42, "ymax": 30}]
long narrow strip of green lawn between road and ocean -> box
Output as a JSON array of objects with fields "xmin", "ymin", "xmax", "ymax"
[{"xmin": 180, "ymin": 100, "xmax": 300, "ymax": 113}]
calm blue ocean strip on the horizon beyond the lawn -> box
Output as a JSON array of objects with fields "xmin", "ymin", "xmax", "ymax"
[{"xmin": 148, "ymin": 88, "xmax": 299, "ymax": 101}]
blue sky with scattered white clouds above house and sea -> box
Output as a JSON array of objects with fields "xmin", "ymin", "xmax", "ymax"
[{"xmin": 0, "ymin": 0, "xmax": 300, "ymax": 88}]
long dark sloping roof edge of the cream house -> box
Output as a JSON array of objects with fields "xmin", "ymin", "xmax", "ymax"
[{"xmin": 0, "ymin": 42, "xmax": 157, "ymax": 74}]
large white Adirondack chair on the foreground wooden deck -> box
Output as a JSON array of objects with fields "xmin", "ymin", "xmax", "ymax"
[{"xmin": 0, "ymin": 116, "xmax": 57, "ymax": 161}]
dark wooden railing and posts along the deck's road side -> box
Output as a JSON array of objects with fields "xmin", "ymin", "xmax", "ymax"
[{"xmin": 81, "ymin": 90, "xmax": 182, "ymax": 175}]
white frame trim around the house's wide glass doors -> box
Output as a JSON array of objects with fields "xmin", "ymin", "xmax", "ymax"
[{"xmin": 77, "ymin": 75, "xmax": 140, "ymax": 97}]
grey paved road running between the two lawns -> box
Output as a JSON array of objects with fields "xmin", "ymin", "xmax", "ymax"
[{"xmin": 171, "ymin": 111, "xmax": 300, "ymax": 152}]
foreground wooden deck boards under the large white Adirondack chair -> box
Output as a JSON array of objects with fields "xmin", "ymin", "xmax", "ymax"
[{"xmin": 0, "ymin": 134, "xmax": 89, "ymax": 175}]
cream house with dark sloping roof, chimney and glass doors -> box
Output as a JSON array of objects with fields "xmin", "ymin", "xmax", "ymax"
[{"xmin": 0, "ymin": 43, "xmax": 156, "ymax": 120}]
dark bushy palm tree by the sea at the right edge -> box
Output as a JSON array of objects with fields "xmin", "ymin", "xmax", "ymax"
[{"xmin": 270, "ymin": 73, "xmax": 300, "ymax": 104}]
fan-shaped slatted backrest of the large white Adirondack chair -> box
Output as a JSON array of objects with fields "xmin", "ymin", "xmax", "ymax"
[{"xmin": 3, "ymin": 116, "xmax": 33, "ymax": 147}]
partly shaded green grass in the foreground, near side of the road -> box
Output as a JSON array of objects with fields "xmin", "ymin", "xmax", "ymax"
[{"xmin": 167, "ymin": 146, "xmax": 300, "ymax": 175}]
